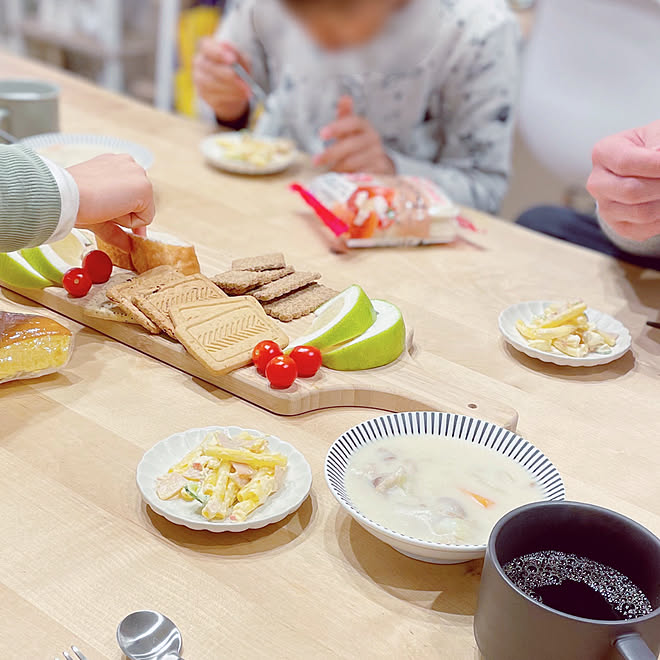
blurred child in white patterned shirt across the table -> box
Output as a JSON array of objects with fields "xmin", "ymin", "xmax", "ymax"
[{"xmin": 194, "ymin": 0, "xmax": 519, "ymax": 212}]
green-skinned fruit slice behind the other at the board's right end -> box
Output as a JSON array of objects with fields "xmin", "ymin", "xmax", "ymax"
[{"xmin": 287, "ymin": 284, "xmax": 376, "ymax": 353}]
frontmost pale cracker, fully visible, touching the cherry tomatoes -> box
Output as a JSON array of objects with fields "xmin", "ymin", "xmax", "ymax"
[{"xmin": 170, "ymin": 296, "xmax": 289, "ymax": 374}]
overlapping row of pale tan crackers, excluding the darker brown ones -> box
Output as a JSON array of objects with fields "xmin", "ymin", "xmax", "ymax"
[{"xmin": 86, "ymin": 266, "xmax": 289, "ymax": 374}]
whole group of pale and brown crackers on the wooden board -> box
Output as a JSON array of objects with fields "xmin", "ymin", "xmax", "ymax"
[{"xmin": 83, "ymin": 253, "xmax": 337, "ymax": 373}]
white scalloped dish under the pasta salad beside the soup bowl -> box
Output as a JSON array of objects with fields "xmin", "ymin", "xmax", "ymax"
[{"xmin": 137, "ymin": 426, "xmax": 312, "ymax": 532}]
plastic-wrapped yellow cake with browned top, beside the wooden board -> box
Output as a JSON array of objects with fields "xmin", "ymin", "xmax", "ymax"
[{"xmin": 0, "ymin": 310, "xmax": 73, "ymax": 384}]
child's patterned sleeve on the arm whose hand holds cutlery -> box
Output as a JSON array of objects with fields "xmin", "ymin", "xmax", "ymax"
[{"xmin": 216, "ymin": 0, "xmax": 270, "ymax": 92}]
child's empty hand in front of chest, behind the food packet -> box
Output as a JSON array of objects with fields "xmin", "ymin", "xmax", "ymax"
[{"xmin": 314, "ymin": 96, "xmax": 396, "ymax": 174}]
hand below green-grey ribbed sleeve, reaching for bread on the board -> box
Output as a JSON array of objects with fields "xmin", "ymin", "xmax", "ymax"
[{"xmin": 68, "ymin": 154, "xmax": 155, "ymax": 252}]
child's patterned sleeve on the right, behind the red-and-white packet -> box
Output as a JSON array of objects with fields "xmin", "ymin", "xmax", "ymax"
[{"xmin": 390, "ymin": 17, "xmax": 520, "ymax": 213}]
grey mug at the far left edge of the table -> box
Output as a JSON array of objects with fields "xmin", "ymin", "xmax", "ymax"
[{"xmin": 0, "ymin": 78, "xmax": 60, "ymax": 138}]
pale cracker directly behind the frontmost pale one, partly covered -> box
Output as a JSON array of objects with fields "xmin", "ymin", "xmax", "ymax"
[{"xmin": 131, "ymin": 273, "xmax": 227, "ymax": 339}]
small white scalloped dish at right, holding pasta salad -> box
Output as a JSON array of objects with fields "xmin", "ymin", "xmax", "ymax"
[{"xmin": 499, "ymin": 300, "xmax": 632, "ymax": 367}]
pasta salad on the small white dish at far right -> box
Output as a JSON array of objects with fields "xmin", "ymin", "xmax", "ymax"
[{"xmin": 516, "ymin": 300, "xmax": 618, "ymax": 358}]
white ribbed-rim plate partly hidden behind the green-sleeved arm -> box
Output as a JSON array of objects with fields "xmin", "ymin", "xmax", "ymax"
[{"xmin": 21, "ymin": 133, "xmax": 154, "ymax": 170}]
